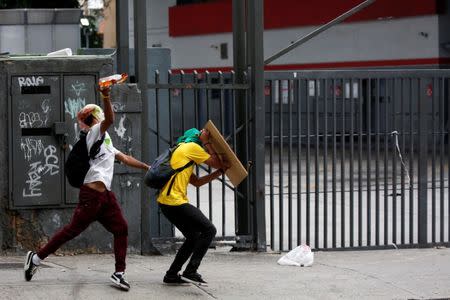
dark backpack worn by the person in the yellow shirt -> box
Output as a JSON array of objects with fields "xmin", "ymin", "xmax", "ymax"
[{"xmin": 144, "ymin": 146, "xmax": 194, "ymax": 196}]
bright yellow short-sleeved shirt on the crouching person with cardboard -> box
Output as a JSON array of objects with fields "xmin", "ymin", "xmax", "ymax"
[{"xmin": 158, "ymin": 143, "xmax": 210, "ymax": 206}]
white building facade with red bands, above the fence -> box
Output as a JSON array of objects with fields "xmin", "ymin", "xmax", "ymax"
[{"xmin": 125, "ymin": 0, "xmax": 450, "ymax": 72}]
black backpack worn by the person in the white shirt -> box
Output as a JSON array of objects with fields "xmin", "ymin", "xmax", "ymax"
[{"xmin": 64, "ymin": 131, "xmax": 105, "ymax": 188}]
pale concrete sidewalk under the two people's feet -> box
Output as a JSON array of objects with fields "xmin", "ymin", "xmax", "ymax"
[{"xmin": 0, "ymin": 247, "xmax": 450, "ymax": 300}]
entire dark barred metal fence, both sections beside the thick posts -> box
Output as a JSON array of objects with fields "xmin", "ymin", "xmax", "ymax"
[{"xmin": 149, "ymin": 70, "xmax": 450, "ymax": 250}]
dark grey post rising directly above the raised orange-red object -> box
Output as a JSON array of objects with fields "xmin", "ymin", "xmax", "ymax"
[{"xmin": 116, "ymin": 0, "xmax": 130, "ymax": 73}]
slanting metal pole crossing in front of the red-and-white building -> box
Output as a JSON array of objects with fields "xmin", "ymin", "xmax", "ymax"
[{"xmin": 264, "ymin": 0, "xmax": 375, "ymax": 65}]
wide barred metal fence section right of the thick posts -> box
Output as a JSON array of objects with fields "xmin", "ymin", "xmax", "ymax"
[{"xmin": 265, "ymin": 70, "xmax": 450, "ymax": 250}]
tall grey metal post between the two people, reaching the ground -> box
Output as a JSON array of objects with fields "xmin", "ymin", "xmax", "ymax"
[{"xmin": 133, "ymin": 0, "xmax": 155, "ymax": 254}]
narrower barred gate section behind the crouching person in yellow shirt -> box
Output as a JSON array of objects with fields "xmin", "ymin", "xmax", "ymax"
[{"xmin": 148, "ymin": 72, "xmax": 249, "ymax": 247}]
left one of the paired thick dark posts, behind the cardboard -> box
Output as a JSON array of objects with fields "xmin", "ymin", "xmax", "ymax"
[{"xmin": 233, "ymin": 0, "xmax": 250, "ymax": 243}]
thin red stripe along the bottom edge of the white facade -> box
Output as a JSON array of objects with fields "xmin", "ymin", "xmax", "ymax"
[{"xmin": 172, "ymin": 57, "xmax": 450, "ymax": 74}]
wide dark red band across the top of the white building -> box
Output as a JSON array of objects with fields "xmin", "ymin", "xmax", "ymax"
[{"xmin": 169, "ymin": 0, "xmax": 443, "ymax": 37}]
